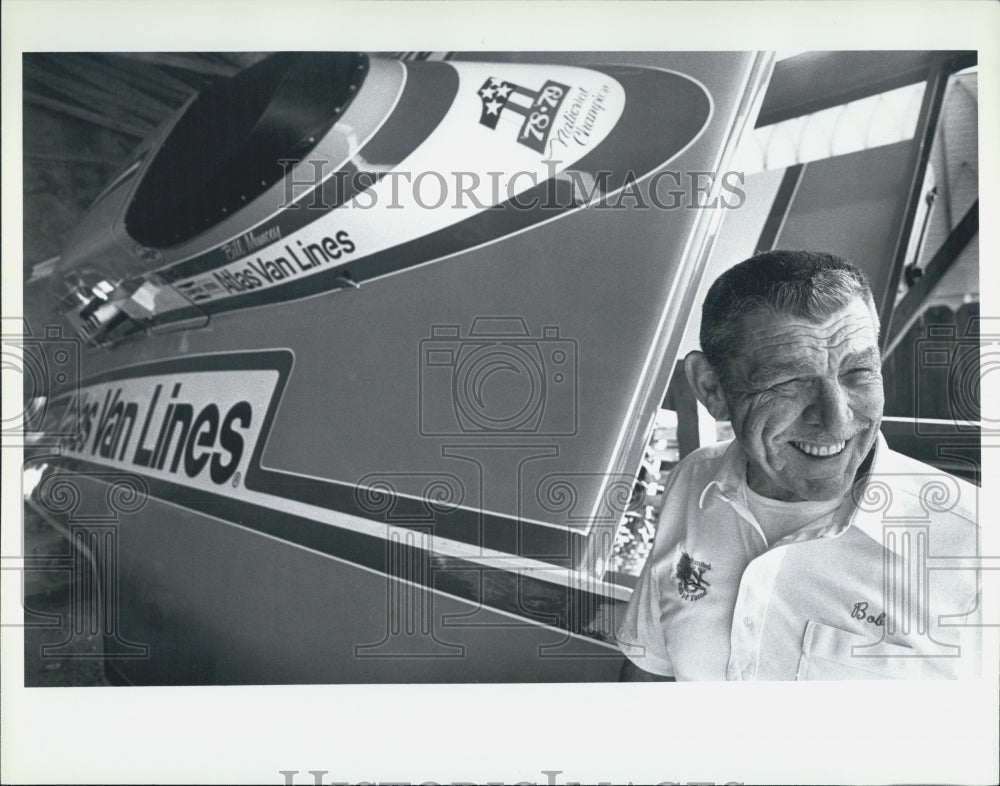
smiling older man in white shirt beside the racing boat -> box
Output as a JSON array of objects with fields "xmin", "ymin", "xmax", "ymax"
[{"xmin": 618, "ymin": 251, "xmax": 979, "ymax": 680}]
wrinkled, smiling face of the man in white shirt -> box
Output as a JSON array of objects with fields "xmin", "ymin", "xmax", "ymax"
[{"xmin": 724, "ymin": 297, "xmax": 884, "ymax": 501}]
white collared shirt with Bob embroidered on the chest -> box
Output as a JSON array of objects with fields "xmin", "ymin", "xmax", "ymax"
[{"xmin": 618, "ymin": 434, "xmax": 980, "ymax": 680}]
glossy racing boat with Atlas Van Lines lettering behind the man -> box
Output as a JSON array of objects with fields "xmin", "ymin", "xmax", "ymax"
[{"xmin": 26, "ymin": 53, "xmax": 769, "ymax": 684}]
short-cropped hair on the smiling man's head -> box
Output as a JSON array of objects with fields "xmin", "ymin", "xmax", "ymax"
[{"xmin": 699, "ymin": 251, "xmax": 878, "ymax": 380}]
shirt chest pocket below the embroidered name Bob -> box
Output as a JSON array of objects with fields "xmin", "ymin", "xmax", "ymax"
[{"xmin": 795, "ymin": 620, "xmax": 944, "ymax": 680}]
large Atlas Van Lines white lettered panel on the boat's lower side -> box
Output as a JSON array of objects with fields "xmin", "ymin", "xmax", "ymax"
[{"xmin": 49, "ymin": 369, "xmax": 279, "ymax": 489}]
